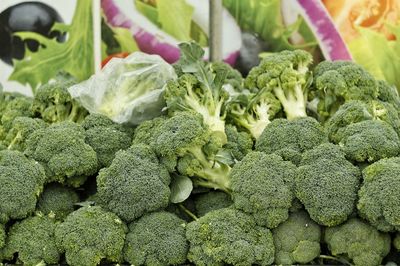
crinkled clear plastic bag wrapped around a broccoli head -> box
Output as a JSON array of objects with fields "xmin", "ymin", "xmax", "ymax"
[{"xmin": 68, "ymin": 52, "xmax": 177, "ymax": 125}]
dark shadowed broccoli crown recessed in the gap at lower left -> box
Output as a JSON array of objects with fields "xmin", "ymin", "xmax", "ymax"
[{"xmin": 36, "ymin": 183, "xmax": 79, "ymax": 220}]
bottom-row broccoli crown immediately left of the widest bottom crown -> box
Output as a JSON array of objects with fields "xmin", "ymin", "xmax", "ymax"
[{"xmin": 123, "ymin": 211, "xmax": 189, "ymax": 265}]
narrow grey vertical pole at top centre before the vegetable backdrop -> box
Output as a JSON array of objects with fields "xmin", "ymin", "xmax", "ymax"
[{"xmin": 209, "ymin": 0, "xmax": 222, "ymax": 62}]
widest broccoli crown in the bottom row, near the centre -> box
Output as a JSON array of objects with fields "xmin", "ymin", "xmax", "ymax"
[{"xmin": 186, "ymin": 208, "xmax": 275, "ymax": 266}]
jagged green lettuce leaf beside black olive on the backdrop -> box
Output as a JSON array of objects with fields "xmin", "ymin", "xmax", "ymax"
[{"xmin": 9, "ymin": 0, "xmax": 94, "ymax": 90}]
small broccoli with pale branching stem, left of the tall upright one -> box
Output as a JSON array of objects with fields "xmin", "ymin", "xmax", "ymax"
[{"xmin": 228, "ymin": 88, "xmax": 281, "ymax": 139}]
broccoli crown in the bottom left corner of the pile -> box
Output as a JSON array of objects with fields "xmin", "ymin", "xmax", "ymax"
[{"xmin": 3, "ymin": 216, "xmax": 61, "ymax": 265}]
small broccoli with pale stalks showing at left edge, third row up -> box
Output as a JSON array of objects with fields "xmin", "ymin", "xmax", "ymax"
[{"xmin": 3, "ymin": 116, "xmax": 47, "ymax": 152}]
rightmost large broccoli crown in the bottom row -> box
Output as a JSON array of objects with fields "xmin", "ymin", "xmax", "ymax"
[{"xmin": 324, "ymin": 218, "xmax": 390, "ymax": 266}]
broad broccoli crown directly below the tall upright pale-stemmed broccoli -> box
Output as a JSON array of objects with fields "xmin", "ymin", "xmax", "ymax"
[{"xmin": 256, "ymin": 117, "xmax": 328, "ymax": 165}]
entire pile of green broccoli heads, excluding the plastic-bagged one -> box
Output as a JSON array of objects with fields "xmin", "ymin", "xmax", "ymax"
[{"xmin": 0, "ymin": 43, "xmax": 400, "ymax": 266}]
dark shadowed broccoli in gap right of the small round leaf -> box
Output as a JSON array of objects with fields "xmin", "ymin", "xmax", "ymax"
[{"xmin": 194, "ymin": 191, "xmax": 233, "ymax": 217}]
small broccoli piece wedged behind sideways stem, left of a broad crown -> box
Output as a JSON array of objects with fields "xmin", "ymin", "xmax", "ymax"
[{"xmin": 223, "ymin": 124, "xmax": 254, "ymax": 161}]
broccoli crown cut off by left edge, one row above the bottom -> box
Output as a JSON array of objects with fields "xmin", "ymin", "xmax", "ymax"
[{"xmin": 0, "ymin": 150, "xmax": 46, "ymax": 223}]
